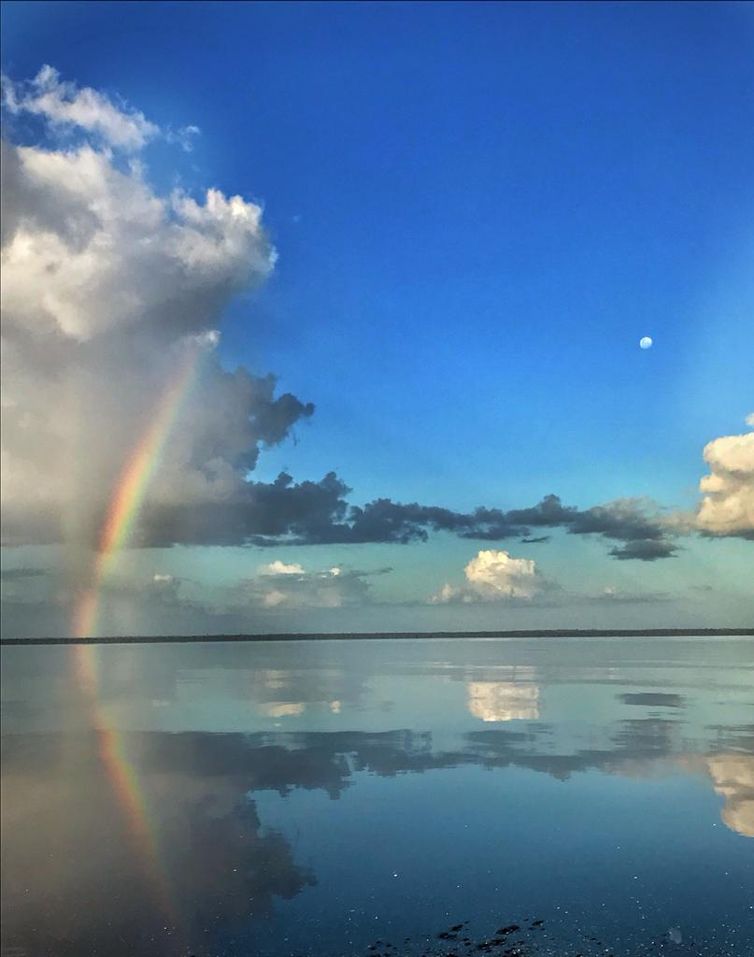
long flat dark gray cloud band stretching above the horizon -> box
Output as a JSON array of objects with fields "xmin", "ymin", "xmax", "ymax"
[{"xmin": 135, "ymin": 486, "xmax": 676, "ymax": 561}]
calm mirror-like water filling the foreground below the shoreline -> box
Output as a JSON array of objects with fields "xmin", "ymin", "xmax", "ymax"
[{"xmin": 2, "ymin": 638, "xmax": 754, "ymax": 957}]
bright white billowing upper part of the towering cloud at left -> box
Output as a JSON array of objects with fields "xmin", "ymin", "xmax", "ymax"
[{"xmin": 2, "ymin": 140, "xmax": 275, "ymax": 342}]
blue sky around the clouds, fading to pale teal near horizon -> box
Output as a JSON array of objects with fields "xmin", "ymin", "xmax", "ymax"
[{"xmin": 2, "ymin": 2, "xmax": 754, "ymax": 628}]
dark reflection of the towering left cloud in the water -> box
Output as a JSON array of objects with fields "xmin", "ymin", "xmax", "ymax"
[{"xmin": 2, "ymin": 733, "xmax": 314, "ymax": 957}]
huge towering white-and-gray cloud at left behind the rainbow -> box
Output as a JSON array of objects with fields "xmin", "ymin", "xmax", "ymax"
[{"xmin": 1, "ymin": 69, "xmax": 312, "ymax": 543}]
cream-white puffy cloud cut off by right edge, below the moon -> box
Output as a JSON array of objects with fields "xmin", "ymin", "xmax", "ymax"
[{"xmin": 697, "ymin": 414, "xmax": 754, "ymax": 538}]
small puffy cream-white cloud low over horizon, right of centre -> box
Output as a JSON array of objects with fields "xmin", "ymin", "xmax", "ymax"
[{"xmin": 430, "ymin": 549, "xmax": 543, "ymax": 604}]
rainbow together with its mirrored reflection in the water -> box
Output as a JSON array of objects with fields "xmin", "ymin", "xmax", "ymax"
[{"xmin": 72, "ymin": 344, "xmax": 205, "ymax": 931}]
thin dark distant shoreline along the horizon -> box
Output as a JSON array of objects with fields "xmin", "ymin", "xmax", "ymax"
[{"xmin": 0, "ymin": 628, "xmax": 754, "ymax": 647}]
